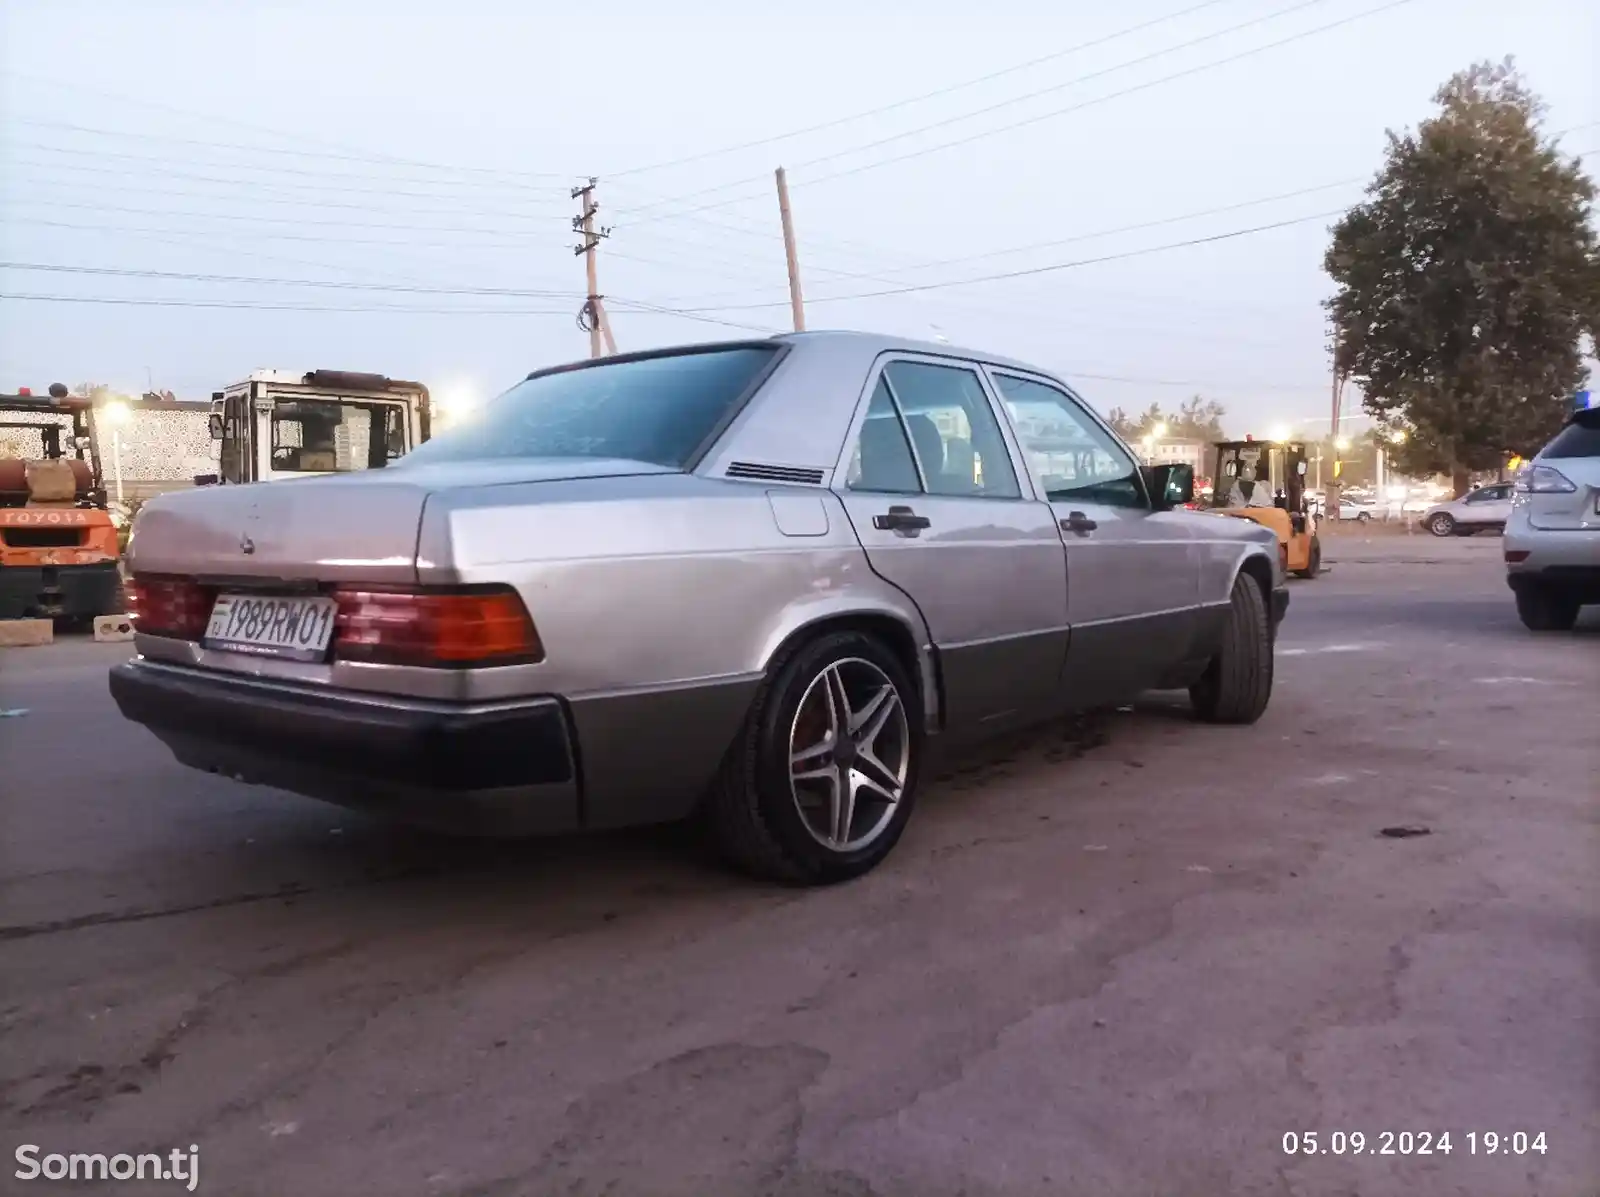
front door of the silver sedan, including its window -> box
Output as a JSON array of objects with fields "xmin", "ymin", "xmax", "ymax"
[{"xmin": 990, "ymin": 371, "xmax": 1200, "ymax": 707}]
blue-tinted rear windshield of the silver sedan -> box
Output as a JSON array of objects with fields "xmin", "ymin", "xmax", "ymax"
[{"xmin": 405, "ymin": 346, "xmax": 778, "ymax": 469}]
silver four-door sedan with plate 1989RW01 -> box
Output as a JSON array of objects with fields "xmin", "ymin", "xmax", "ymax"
[{"xmin": 110, "ymin": 333, "xmax": 1288, "ymax": 883}]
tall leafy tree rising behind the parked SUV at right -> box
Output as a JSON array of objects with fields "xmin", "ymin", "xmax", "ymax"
[{"xmin": 1325, "ymin": 59, "xmax": 1600, "ymax": 491}]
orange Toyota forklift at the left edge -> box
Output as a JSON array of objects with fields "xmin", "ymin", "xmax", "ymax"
[{"xmin": 0, "ymin": 382, "xmax": 122, "ymax": 624}]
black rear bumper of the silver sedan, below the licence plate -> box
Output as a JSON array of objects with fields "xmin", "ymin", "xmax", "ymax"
[{"xmin": 110, "ymin": 659, "xmax": 579, "ymax": 835}]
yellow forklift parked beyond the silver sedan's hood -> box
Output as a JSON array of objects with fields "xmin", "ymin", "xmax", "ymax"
[{"xmin": 1200, "ymin": 437, "xmax": 1322, "ymax": 578}]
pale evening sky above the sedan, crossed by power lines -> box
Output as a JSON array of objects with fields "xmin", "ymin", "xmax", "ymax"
[{"xmin": 0, "ymin": 0, "xmax": 1600, "ymax": 435}]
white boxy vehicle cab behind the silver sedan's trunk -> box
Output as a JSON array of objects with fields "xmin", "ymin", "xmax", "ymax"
[{"xmin": 209, "ymin": 370, "xmax": 432, "ymax": 483}]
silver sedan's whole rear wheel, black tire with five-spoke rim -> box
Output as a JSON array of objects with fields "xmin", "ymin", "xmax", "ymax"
[{"xmin": 704, "ymin": 632, "xmax": 923, "ymax": 885}]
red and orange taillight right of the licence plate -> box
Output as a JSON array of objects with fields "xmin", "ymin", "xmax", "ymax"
[{"xmin": 333, "ymin": 587, "xmax": 544, "ymax": 669}]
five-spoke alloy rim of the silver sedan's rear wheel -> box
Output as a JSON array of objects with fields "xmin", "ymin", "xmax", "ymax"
[{"xmin": 789, "ymin": 658, "xmax": 910, "ymax": 853}]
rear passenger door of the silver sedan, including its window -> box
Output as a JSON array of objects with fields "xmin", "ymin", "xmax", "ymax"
[{"xmin": 840, "ymin": 366, "xmax": 1067, "ymax": 738}]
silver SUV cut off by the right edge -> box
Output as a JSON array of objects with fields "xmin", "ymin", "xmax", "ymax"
[{"xmin": 1504, "ymin": 390, "xmax": 1600, "ymax": 632}]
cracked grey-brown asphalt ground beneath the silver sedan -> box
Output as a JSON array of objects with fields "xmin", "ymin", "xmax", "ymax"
[{"xmin": 0, "ymin": 538, "xmax": 1600, "ymax": 1197}]
